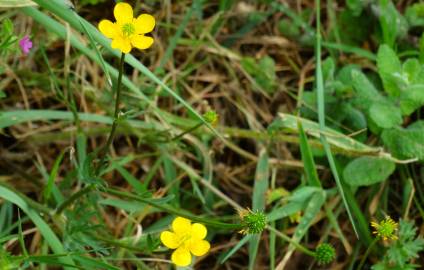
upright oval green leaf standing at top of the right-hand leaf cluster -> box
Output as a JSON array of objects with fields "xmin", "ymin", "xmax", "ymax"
[{"xmin": 377, "ymin": 44, "xmax": 402, "ymax": 96}]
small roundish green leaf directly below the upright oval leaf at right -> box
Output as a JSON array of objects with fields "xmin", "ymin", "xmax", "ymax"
[{"xmin": 369, "ymin": 102, "xmax": 403, "ymax": 128}]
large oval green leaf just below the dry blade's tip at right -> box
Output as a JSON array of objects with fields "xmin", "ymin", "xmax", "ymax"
[{"xmin": 343, "ymin": 156, "xmax": 396, "ymax": 186}]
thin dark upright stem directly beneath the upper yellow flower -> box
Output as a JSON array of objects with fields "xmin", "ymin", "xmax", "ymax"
[{"xmin": 96, "ymin": 53, "xmax": 125, "ymax": 175}]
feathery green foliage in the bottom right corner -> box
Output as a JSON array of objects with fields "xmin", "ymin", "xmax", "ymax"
[{"xmin": 372, "ymin": 220, "xmax": 424, "ymax": 270}]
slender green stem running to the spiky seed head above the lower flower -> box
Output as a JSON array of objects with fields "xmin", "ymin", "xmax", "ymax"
[{"xmin": 103, "ymin": 188, "xmax": 242, "ymax": 230}]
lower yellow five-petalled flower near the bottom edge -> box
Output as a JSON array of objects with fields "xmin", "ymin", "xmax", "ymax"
[{"xmin": 160, "ymin": 217, "xmax": 210, "ymax": 266}]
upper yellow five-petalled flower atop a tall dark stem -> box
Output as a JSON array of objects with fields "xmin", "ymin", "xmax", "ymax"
[{"xmin": 99, "ymin": 3, "xmax": 155, "ymax": 53}]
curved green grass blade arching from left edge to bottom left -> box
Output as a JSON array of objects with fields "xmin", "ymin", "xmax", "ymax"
[{"xmin": 0, "ymin": 186, "xmax": 75, "ymax": 269}]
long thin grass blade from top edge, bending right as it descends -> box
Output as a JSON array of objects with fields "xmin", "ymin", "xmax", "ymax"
[{"xmin": 315, "ymin": 0, "xmax": 358, "ymax": 237}]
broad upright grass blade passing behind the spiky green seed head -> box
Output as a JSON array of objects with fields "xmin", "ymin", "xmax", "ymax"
[{"xmin": 249, "ymin": 150, "xmax": 269, "ymax": 270}]
